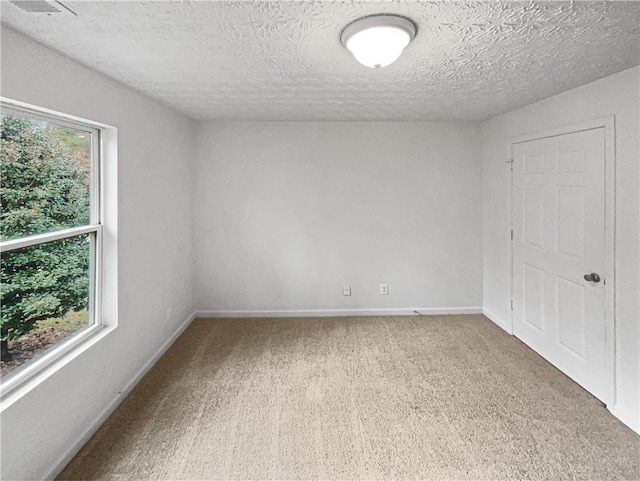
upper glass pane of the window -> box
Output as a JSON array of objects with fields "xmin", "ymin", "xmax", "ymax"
[{"xmin": 0, "ymin": 115, "xmax": 91, "ymax": 241}]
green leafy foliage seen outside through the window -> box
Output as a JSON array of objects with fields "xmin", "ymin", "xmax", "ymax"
[{"xmin": 0, "ymin": 116, "xmax": 90, "ymax": 359}]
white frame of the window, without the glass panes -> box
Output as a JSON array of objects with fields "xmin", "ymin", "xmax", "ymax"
[{"xmin": 0, "ymin": 97, "xmax": 107, "ymax": 396}]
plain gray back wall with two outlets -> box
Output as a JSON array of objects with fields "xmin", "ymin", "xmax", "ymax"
[{"xmin": 195, "ymin": 122, "xmax": 482, "ymax": 314}]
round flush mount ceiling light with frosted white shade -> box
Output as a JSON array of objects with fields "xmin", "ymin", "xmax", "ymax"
[{"xmin": 340, "ymin": 15, "xmax": 416, "ymax": 68}]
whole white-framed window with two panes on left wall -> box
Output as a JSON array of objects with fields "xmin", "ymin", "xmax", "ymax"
[{"xmin": 0, "ymin": 101, "xmax": 103, "ymax": 390}]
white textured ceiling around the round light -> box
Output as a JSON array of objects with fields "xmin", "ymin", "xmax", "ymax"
[{"xmin": 2, "ymin": 0, "xmax": 640, "ymax": 121}]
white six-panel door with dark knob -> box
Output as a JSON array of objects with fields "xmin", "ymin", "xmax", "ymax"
[{"xmin": 512, "ymin": 128, "xmax": 608, "ymax": 401}]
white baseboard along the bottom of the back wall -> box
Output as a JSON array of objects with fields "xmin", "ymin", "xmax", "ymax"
[{"xmin": 196, "ymin": 307, "xmax": 482, "ymax": 318}]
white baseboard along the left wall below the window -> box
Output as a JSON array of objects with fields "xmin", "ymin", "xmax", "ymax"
[{"xmin": 43, "ymin": 312, "xmax": 196, "ymax": 480}]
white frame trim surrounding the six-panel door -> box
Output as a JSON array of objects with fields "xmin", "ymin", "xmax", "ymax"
[{"xmin": 507, "ymin": 116, "xmax": 616, "ymax": 404}]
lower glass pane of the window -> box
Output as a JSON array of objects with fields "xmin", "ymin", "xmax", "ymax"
[{"xmin": 0, "ymin": 233, "xmax": 95, "ymax": 380}]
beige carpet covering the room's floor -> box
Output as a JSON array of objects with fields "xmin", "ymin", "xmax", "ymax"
[{"xmin": 59, "ymin": 315, "xmax": 640, "ymax": 480}]
